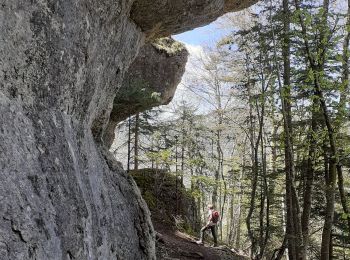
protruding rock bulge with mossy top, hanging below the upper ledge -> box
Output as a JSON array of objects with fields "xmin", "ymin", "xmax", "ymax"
[{"xmin": 104, "ymin": 38, "xmax": 188, "ymax": 147}]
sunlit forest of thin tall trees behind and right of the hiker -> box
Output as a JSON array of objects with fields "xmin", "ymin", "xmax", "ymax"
[{"xmin": 111, "ymin": 0, "xmax": 350, "ymax": 260}]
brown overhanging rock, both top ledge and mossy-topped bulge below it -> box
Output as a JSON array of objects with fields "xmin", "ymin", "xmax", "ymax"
[{"xmin": 104, "ymin": 0, "xmax": 257, "ymax": 147}]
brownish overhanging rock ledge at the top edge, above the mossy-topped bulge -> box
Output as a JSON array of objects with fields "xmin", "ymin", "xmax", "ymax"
[{"xmin": 131, "ymin": 0, "xmax": 258, "ymax": 39}]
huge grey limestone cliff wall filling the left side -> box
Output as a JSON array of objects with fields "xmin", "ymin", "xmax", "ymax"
[{"xmin": 0, "ymin": 0, "xmax": 258, "ymax": 260}]
